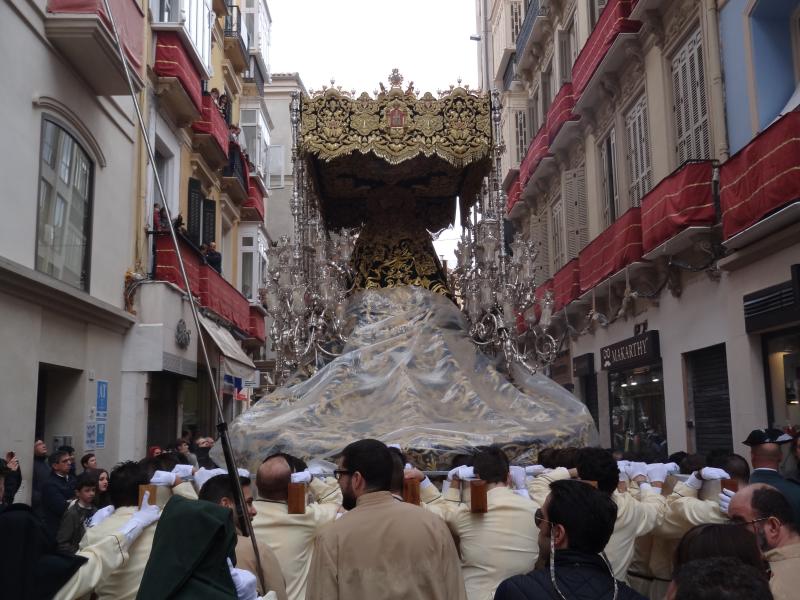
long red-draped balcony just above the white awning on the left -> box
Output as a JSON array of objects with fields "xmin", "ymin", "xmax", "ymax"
[{"xmin": 155, "ymin": 234, "xmax": 250, "ymax": 332}]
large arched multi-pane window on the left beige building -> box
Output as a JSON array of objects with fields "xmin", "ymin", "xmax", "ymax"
[{"xmin": 36, "ymin": 119, "xmax": 93, "ymax": 290}]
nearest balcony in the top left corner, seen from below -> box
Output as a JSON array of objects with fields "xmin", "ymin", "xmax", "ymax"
[{"xmin": 45, "ymin": 0, "xmax": 144, "ymax": 96}]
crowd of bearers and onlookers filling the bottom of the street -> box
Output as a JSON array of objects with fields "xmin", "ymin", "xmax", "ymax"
[{"xmin": 0, "ymin": 429, "xmax": 800, "ymax": 600}]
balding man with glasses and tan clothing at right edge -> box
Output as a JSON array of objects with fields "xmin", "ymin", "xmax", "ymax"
[{"xmin": 728, "ymin": 483, "xmax": 800, "ymax": 600}]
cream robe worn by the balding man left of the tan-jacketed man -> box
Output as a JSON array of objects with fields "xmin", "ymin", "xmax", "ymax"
[{"xmin": 253, "ymin": 479, "xmax": 342, "ymax": 600}]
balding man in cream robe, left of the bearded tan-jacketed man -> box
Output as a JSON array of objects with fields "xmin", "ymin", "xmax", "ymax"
[{"xmin": 253, "ymin": 454, "xmax": 342, "ymax": 600}]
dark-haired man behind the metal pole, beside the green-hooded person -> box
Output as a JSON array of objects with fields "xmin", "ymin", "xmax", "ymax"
[{"xmin": 200, "ymin": 474, "xmax": 286, "ymax": 600}]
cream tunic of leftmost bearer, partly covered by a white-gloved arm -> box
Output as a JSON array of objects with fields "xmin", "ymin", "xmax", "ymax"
[{"xmin": 80, "ymin": 506, "xmax": 157, "ymax": 600}]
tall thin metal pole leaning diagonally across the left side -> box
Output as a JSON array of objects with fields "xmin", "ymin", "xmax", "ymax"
[{"xmin": 103, "ymin": 0, "xmax": 267, "ymax": 591}]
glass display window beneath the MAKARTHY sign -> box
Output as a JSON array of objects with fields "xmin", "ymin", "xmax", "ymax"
[{"xmin": 608, "ymin": 364, "xmax": 667, "ymax": 460}]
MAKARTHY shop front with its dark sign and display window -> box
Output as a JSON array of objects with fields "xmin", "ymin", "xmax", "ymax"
[{"xmin": 600, "ymin": 331, "xmax": 667, "ymax": 460}]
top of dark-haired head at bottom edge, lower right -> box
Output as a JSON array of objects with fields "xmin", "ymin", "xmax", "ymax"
[{"xmin": 666, "ymin": 557, "xmax": 778, "ymax": 600}]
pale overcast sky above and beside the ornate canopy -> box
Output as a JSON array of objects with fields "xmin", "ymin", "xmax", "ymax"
[{"xmin": 268, "ymin": 0, "xmax": 478, "ymax": 264}]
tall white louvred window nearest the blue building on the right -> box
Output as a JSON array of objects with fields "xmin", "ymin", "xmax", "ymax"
[{"xmin": 672, "ymin": 29, "xmax": 711, "ymax": 165}]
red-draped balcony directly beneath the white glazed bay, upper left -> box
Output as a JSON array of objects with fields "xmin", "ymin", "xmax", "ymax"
[{"xmin": 153, "ymin": 31, "xmax": 203, "ymax": 127}]
